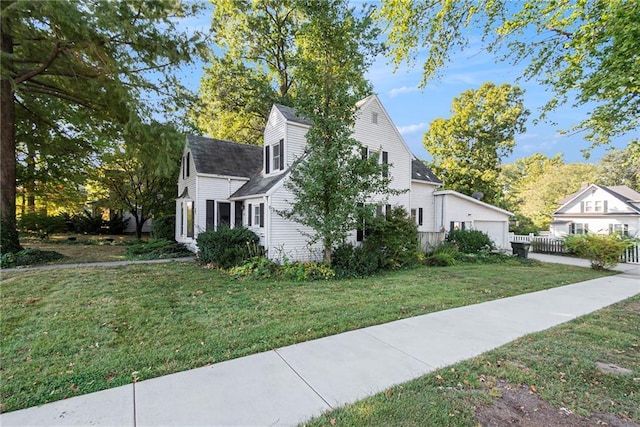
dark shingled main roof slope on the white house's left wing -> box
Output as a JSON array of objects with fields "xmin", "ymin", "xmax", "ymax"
[{"xmin": 187, "ymin": 135, "xmax": 262, "ymax": 178}]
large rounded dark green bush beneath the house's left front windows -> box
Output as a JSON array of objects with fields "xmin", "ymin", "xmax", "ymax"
[{"xmin": 196, "ymin": 227, "xmax": 260, "ymax": 268}]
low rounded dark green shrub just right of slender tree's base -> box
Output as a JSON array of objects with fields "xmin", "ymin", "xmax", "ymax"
[{"xmin": 331, "ymin": 243, "xmax": 380, "ymax": 278}]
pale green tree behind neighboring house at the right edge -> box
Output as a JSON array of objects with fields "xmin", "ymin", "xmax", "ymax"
[{"xmin": 598, "ymin": 143, "xmax": 640, "ymax": 191}]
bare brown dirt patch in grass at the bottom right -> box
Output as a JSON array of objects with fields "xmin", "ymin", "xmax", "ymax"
[{"xmin": 475, "ymin": 382, "xmax": 640, "ymax": 427}]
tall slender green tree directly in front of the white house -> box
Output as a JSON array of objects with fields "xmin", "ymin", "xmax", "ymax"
[{"xmin": 281, "ymin": 0, "xmax": 390, "ymax": 264}]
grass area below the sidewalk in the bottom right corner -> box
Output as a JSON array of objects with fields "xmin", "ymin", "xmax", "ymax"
[{"xmin": 306, "ymin": 296, "xmax": 640, "ymax": 427}]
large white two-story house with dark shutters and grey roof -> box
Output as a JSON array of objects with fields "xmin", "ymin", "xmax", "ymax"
[{"xmin": 176, "ymin": 95, "xmax": 511, "ymax": 260}]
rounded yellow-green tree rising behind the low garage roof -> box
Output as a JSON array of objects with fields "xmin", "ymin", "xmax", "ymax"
[{"xmin": 423, "ymin": 83, "xmax": 529, "ymax": 203}]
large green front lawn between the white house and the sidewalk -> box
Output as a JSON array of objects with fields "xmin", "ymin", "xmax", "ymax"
[{"xmin": 0, "ymin": 261, "xmax": 607, "ymax": 411}]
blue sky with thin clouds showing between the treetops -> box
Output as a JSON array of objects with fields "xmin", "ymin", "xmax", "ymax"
[{"xmin": 176, "ymin": 1, "xmax": 640, "ymax": 164}]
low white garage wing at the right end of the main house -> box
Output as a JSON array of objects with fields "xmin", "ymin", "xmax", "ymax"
[{"xmin": 433, "ymin": 190, "xmax": 513, "ymax": 249}]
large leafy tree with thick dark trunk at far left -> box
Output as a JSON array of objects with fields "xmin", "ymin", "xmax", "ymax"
[{"xmin": 0, "ymin": 0, "xmax": 202, "ymax": 253}]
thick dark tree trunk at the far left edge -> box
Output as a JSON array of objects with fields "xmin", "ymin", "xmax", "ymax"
[{"xmin": 0, "ymin": 17, "xmax": 20, "ymax": 253}]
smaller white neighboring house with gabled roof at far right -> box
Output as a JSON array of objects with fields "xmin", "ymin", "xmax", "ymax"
[{"xmin": 550, "ymin": 184, "xmax": 640, "ymax": 237}]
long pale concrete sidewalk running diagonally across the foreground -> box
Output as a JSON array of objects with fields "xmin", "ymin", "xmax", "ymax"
[{"xmin": 0, "ymin": 254, "xmax": 640, "ymax": 426}]
